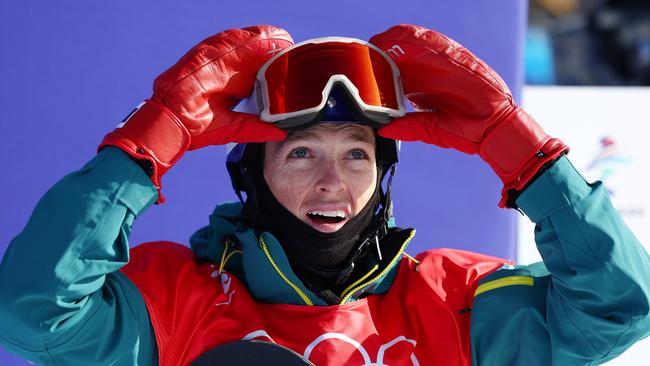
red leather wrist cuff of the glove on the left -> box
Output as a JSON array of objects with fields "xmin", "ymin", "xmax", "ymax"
[{"xmin": 97, "ymin": 99, "xmax": 191, "ymax": 203}]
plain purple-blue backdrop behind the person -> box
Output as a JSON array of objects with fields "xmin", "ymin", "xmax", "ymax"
[{"xmin": 0, "ymin": 0, "xmax": 527, "ymax": 365}]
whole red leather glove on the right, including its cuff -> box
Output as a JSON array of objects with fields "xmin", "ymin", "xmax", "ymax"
[{"xmin": 370, "ymin": 24, "xmax": 568, "ymax": 207}]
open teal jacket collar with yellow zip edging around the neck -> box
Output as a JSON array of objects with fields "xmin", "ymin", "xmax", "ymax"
[{"xmin": 190, "ymin": 203, "xmax": 415, "ymax": 305}]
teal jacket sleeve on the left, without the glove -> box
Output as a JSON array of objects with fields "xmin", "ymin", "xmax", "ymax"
[{"xmin": 0, "ymin": 147, "xmax": 157, "ymax": 365}]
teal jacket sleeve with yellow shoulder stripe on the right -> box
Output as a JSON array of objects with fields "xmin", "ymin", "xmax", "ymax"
[{"xmin": 471, "ymin": 158, "xmax": 650, "ymax": 365}]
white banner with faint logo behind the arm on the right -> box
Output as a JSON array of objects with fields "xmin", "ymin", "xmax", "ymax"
[{"xmin": 517, "ymin": 87, "xmax": 650, "ymax": 365}]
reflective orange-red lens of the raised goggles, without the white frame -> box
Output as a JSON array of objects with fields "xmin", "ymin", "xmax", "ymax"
[{"xmin": 258, "ymin": 41, "xmax": 403, "ymax": 116}]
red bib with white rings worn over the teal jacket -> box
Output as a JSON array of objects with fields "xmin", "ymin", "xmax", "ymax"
[{"xmin": 123, "ymin": 243, "xmax": 504, "ymax": 366}]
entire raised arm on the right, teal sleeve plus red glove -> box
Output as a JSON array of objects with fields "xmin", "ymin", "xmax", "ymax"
[{"xmin": 371, "ymin": 25, "xmax": 650, "ymax": 365}]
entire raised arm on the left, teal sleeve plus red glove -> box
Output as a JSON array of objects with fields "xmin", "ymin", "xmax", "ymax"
[{"xmin": 0, "ymin": 26, "xmax": 292, "ymax": 365}]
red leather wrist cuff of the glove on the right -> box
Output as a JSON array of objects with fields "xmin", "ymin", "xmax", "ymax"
[{"xmin": 479, "ymin": 107, "xmax": 569, "ymax": 207}]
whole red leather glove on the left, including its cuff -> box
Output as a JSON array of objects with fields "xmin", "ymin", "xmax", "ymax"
[{"xmin": 99, "ymin": 25, "xmax": 293, "ymax": 203}]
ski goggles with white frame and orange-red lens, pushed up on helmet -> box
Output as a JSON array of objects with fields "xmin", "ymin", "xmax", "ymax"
[{"xmin": 255, "ymin": 37, "xmax": 405, "ymax": 128}]
